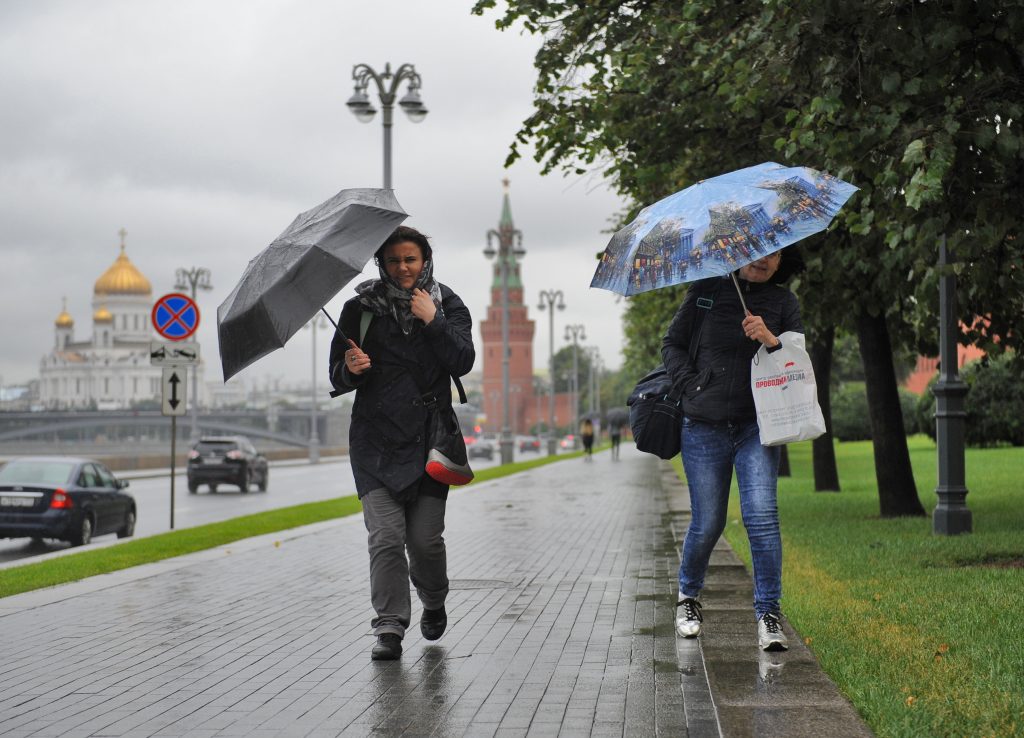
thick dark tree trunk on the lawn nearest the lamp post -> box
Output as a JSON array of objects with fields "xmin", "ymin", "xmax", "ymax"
[{"xmin": 857, "ymin": 309, "xmax": 925, "ymax": 518}]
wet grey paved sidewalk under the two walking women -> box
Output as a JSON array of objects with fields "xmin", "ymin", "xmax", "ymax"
[{"xmin": 0, "ymin": 447, "xmax": 869, "ymax": 738}]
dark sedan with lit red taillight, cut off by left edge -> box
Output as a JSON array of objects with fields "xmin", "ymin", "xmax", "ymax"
[{"xmin": 0, "ymin": 457, "xmax": 136, "ymax": 546}]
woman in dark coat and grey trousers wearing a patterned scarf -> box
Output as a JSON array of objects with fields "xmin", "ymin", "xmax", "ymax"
[{"xmin": 330, "ymin": 226, "xmax": 475, "ymax": 660}]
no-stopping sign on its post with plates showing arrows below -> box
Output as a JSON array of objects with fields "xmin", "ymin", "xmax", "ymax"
[{"xmin": 150, "ymin": 293, "xmax": 199, "ymax": 530}]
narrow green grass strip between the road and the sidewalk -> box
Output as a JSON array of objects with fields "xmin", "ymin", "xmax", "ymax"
[{"xmin": 0, "ymin": 444, "xmax": 593, "ymax": 597}]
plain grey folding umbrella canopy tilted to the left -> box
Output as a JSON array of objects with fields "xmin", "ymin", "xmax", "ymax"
[{"xmin": 217, "ymin": 188, "xmax": 408, "ymax": 382}]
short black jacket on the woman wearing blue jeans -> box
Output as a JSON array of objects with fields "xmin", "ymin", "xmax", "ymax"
[{"xmin": 662, "ymin": 276, "xmax": 804, "ymax": 424}]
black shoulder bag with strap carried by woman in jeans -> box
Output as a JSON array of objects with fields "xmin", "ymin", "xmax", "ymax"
[{"xmin": 626, "ymin": 280, "xmax": 721, "ymax": 459}]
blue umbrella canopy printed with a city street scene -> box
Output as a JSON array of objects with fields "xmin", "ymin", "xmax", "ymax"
[{"xmin": 590, "ymin": 162, "xmax": 857, "ymax": 295}]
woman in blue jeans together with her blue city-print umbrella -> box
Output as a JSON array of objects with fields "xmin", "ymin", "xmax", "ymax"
[{"xmin": 591, "ymin": 162, "xmax": 856, "ymax": 651}]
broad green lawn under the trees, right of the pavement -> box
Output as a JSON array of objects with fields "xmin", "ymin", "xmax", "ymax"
[{"xmin": 684, "ymin": 436, "xmax": 1024, "ymax": 737}]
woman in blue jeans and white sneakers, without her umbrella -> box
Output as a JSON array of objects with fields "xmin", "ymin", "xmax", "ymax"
[{"xmin": 662, "ymin": 252, "xmax": 804, "ymax": 651}]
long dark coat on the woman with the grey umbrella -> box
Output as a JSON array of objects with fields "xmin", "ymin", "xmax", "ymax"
[{"xmin": 330, "ymin": 285, "xmax": 475, "ymax": 501}]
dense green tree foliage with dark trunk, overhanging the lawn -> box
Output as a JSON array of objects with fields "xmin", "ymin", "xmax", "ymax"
[{"xmin": 474, "ymin": 0, "xmax": 1024, "ymax": 515}]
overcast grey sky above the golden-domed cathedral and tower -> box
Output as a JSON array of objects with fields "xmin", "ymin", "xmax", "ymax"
[{"xmin": 0, "ymin": 0, "xmax": 623, "ymax": 385}]
